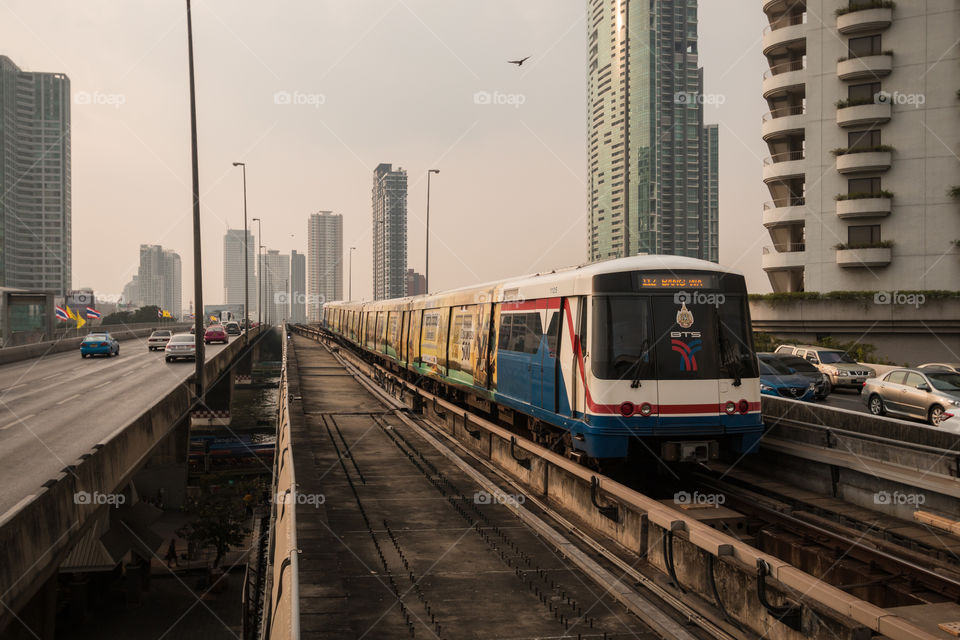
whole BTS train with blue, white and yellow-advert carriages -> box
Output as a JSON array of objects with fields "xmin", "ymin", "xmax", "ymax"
[{"xmin": 322, "ymin": 255, "xmax": 763, "ymax": 461}]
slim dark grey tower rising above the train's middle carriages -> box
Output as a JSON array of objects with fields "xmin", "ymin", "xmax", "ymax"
[{"xmin": 373, "ymin": 164, "xmax": 407, "ymax": 300}]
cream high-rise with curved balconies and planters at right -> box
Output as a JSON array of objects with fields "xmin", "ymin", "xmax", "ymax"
[{"xmin": 761, "ymin": 0, "xmax": 960, "ymax": 292}]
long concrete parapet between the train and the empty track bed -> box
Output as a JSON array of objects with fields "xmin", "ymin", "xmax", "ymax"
[{"xmin": 293, "ymin": 325, "xmax": 936, "ymax": 640}]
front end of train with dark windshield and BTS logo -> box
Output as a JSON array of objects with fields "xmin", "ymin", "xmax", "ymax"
[{"xmin": 578, "ymin": 270, "xmax": 763, "ymax": 461}]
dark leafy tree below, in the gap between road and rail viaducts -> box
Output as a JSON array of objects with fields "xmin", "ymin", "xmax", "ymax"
[{"xmin": 177, "ymin": 480, "xmax": 262, "ymax": 569}]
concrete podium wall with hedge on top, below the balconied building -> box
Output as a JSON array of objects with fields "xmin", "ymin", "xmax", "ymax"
[{"xmin": 750, "ymin": 292, "xmax": 960, "ymax": 365}]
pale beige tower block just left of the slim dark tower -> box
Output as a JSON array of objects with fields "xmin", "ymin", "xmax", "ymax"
[{"xmin": 306, "ymin": 211, "xmax": 343, "ymax": 322}]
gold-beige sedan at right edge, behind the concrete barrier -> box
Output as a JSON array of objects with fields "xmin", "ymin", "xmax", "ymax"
[{"xmin": 863, "ymin": 369, "xmax": 960, "ymax": 426}]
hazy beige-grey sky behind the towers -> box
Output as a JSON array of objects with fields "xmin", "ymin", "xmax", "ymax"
[{"xmin": 0, "ymin": 0, "xmax": 769, "ymax": 306}]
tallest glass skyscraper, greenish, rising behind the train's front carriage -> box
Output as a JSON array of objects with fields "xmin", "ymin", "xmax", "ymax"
[{"xmin": 587, "ymin": 0, "xmax": 711, "ymax": 260}]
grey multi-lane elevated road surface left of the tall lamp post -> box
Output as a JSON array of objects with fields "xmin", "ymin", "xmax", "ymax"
[{"xmin": 0, "ymin": 336, "xmax": 240, "ymax": 519}]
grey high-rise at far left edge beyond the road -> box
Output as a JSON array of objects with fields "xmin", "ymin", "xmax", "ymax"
[{"xmin": 0, "ymin": 56, "xmax": 72, "ymax": 295}]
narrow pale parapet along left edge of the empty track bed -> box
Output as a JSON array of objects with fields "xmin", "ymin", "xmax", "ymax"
[{"xmin": 260, "ymin": 332, "xmax": 300, "ymax": 640}]
